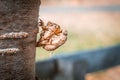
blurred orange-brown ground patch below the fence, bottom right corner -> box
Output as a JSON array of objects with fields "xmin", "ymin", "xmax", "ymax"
[{"xmin": 86, "ymin": 66, "xmax": 120, "ymax": 80}]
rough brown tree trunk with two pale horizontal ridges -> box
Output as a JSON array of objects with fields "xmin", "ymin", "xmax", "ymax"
[{"xmin": 0, "ymin": 0, "xmax": 40, "ymax": 80}]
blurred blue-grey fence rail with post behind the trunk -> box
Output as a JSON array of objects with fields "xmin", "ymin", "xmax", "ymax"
[{"xmin": 36, "ymin": 45, "xmax": 120, "ymax": 80}]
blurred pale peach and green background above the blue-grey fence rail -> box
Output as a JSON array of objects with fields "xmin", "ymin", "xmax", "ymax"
[{"xmin": 36, "ymin": 0, "xmax": 120, "ymax": 61}]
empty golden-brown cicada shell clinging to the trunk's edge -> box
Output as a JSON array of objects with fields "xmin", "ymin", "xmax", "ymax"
[{"xmin": 37, "ymin": 20, "xmax": 67, "ymax": 51}]
